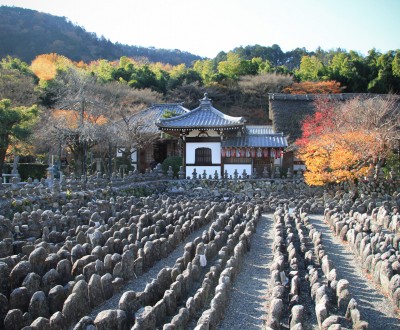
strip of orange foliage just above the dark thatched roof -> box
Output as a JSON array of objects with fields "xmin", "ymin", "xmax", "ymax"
[{"xmin": 283, "ymin": 80, "xmax": 343, "ymax": 94}]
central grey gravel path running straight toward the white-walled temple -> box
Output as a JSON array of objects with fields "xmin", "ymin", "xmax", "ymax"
[{"xmin": 219, "ymin": 214, "xmax": 273, "ymax": 330}]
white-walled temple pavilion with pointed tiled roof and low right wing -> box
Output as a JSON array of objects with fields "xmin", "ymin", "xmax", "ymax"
[{"xmin": 155, "ymin": 93, "xmax": 288, "ymax": 177}]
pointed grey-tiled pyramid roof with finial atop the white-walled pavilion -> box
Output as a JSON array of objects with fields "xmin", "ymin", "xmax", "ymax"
[{"xmin": 156, "ymin": 93, "xmax": 245, "ymax": 130}]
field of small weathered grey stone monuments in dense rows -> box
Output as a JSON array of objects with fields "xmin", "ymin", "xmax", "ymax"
[{"xmin": 0, "ymin": 168, "xmax": 400, "ymax": 330}]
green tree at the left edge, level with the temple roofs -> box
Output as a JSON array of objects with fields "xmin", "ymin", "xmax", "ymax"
[{"xmin": 0, "ymin": 99, "xmax": 38, "ymax": 176}]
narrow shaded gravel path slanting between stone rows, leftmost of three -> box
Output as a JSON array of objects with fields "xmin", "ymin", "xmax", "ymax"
[{"xmin": 76, "ymin": 222, "xmax": 212, "ymax": 326}]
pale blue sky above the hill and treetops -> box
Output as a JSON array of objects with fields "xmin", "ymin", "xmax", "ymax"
[{"xmin": 0, "ymin": 0, "xmax": 400, "ymax": 58}]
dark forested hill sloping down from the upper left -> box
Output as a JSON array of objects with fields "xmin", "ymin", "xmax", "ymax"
[{"xmin": 0, "ymin": 6, "xmax": 201, "ymax": 65}]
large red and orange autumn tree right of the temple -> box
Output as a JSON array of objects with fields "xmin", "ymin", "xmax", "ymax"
[{"xmin": 295, "ymin": 96, "xmax": 400, "ymax": 185}]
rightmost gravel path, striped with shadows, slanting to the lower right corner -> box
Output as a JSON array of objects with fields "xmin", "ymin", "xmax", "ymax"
[{"xmin": 309, "ymin": 215, "xmax": 400, "ymax": 330}]
